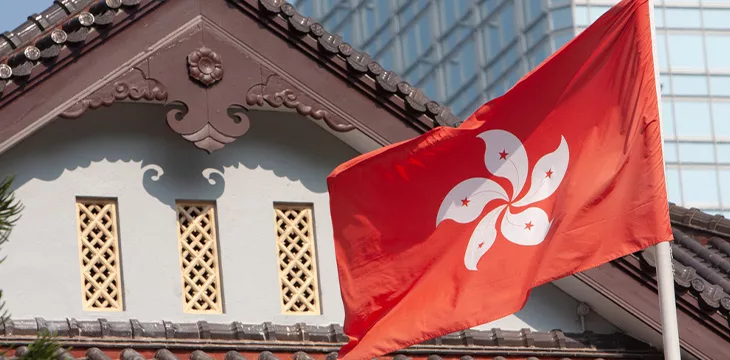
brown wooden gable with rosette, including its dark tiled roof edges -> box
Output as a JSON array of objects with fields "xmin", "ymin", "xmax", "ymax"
[{"xmin": 0, "ymin": 0, "xmax": 458, "ymax": 152}]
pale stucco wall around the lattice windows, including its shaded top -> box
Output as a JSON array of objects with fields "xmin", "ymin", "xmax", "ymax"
[{"xmin": 0, "ymin": 104, "xmax": 613, "ymax": 332}]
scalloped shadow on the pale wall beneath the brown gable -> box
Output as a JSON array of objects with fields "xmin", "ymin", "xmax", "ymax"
[{"xmin": 0, "ymin": 103, "xmax": 358, "ymax": 208}]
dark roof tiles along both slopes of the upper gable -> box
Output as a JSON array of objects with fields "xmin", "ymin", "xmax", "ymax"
[{"xmin": 0, "ymin": 0, "xmax": 461, "ymax": 126}]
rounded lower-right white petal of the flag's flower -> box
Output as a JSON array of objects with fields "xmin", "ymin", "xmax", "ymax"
[{"xmin": 501, "ymin": 207, "xmax": 550, "ymax": 246}]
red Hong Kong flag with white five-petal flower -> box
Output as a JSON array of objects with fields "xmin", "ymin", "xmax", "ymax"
[{"xmin": 328, "ymin": 0, "xmax": 672, "ymax": 359}]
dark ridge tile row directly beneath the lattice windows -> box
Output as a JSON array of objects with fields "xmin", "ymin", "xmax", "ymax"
[{"xmin": 0, "ymin": 318, "xmax": 656, "ymax": 352}]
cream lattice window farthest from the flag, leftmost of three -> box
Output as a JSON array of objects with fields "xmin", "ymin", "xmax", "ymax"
[{"xmin": 76, "ymin": 199, "xmax": 123, "ymax": 311}]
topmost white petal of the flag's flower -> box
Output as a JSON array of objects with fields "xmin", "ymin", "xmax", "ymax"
[{"xmin": 478, "ymin": 130, "xmax": 528, "ymax": 199}]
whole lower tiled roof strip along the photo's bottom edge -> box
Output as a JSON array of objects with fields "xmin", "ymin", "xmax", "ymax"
[{"xmin": 0, "ymin": 318, "xmax": 659, "ymax": 360}]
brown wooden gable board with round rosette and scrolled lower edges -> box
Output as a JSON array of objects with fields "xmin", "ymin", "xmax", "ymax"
[{"xmin": 61, "ymin": 20, "xmax": 355, "ymax": 153}]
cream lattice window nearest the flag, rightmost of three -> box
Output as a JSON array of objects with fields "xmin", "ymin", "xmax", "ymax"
[{"xmin": 274, "ymin": 204, "xmax": 320, "ymax": 314}]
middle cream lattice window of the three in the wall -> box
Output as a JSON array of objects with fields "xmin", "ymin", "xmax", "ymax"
[{"xmin": 177, "ymin": 202, "xmax": 223, "ymax": 314}]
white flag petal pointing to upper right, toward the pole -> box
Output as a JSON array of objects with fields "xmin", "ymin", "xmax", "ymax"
[{"xmin": 514, "ymin": 136, "xmax": 570, "ymax": 206}]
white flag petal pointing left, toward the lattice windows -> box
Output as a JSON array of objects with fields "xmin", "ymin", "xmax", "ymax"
[{"xmin": 436, "ymin": 178, "xmax": 507, "ymax": 225}]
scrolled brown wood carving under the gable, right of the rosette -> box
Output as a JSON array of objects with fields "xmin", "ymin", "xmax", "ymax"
[{"xmin": 246, "ymin": 73, "xmax": 354, "ymax": 132}]
